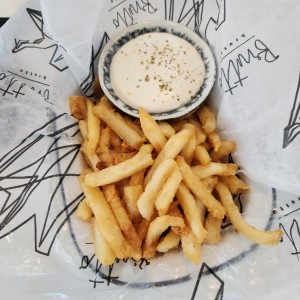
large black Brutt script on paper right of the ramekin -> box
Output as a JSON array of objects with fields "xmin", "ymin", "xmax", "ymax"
[{"xmin": 219, "ymin": 36, "xmax": 279, "ymax": 95}]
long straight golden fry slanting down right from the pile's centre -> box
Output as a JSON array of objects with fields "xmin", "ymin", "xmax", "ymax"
[{"xmin": 176, "ymin": 156, "xmax": 225, "ymax": 219}]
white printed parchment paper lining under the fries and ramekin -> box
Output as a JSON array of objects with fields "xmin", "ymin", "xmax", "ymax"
[{"xmin": 0, "ymin": 0, "xmax": 300, "ymax": 299}]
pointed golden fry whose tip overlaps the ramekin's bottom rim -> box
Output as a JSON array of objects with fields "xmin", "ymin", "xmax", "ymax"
[{"xmin": 139, "ymin": 107, "xmax": 167, "ymax": 153}]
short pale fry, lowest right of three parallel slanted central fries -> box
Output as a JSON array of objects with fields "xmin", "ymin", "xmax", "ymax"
[{"xmin": 155, "ymin": 167, "xmax": 182, "ymax": 216}]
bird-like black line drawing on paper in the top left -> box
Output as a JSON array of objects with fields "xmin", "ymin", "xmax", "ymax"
[{"xmin": 12, "ymin": 8, "xmax": 68, "ymax": 72}]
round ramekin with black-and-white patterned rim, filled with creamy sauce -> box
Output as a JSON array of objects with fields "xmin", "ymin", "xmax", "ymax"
[{"xmin": 99, "ymin": 21, "xmax": 216, "ymax": 120}]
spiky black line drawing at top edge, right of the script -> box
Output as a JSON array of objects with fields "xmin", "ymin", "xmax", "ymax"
[{"xmin": 165, "ymin": 0, "xmax": 226, "ymax": 42}]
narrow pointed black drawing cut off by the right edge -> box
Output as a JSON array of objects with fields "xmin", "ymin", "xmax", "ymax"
[{"xmin": 282, "ymin": 73, "xmax": 300, "ymax": 148}]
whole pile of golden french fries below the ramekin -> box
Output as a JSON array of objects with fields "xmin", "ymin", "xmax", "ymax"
[{"xmin": 69, "ymin": 96, "xmax": 282, "ymax": 265}]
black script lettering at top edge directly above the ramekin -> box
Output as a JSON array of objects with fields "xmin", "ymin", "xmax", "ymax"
[{"xmin": 113, "ymin": 0, "xmax": 157, "ymax": 28}]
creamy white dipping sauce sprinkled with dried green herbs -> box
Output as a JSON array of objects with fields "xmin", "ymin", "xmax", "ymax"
[{"xmin": 110, "ymin": 32, "xmax": 205, "ymax": 113}]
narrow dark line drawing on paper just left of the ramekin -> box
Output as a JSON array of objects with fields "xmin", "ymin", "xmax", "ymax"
[{"xmin": 80, "ymin": 32, "xmax": 109, "ymax": 97}]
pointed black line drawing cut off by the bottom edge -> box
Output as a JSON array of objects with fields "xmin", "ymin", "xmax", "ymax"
[{"xmin": 191, "ymin": 263, "xmax": 224, "ymax": 300}]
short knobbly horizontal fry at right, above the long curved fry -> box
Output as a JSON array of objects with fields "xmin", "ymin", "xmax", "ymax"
[{"xmin": 192, "ymin": 162, "xmax": 238, "ymax": 179}]
